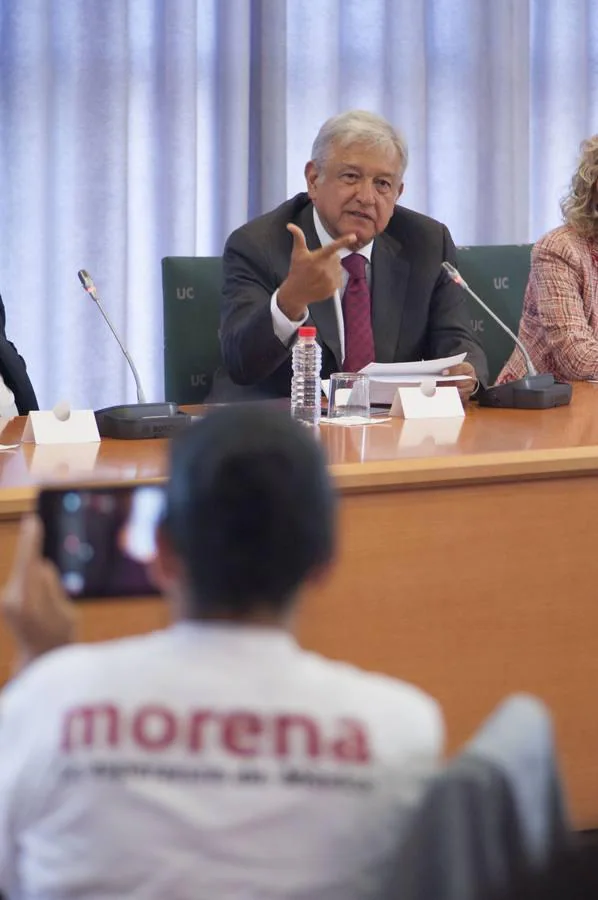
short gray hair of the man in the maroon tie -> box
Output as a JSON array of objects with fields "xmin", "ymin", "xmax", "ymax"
[{"xmin": 311, "ymin": 109, "xmax": 409, "ymax": 178}]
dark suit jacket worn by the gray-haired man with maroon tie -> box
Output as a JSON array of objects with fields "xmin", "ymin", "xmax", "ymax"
[{"xmin": 210, "ymin": 194, "xmax": 488, "ymax": 400}]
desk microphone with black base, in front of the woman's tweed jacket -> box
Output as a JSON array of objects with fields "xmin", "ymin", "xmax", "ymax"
[{"xmin": 442, "ymin": 262, "xmax": 571, "ymax": 409}]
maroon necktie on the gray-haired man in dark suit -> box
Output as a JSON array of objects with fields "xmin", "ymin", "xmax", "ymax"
[{"xmin": 341, "ymin": 253, "xmax": 375, "ymax": 372}]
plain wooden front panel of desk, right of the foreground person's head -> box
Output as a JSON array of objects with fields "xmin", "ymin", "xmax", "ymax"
[{"xmin": 299, "ymin": 475, "xmax": 598, "ymax": 827}]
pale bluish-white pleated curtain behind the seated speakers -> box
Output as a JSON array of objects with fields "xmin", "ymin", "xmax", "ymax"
[{"xmin": 0, "ymin": 0, "xmax": 598, "ymax": 408}]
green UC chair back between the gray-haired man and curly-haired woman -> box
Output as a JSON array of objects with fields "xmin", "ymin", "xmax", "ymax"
[{"xmin": 457, "ymin": 244, "xmax": 531, "ymax": 384}]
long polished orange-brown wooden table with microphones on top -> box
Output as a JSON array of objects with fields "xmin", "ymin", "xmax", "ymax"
[{"xmin": 0, "ymin": 384, "xmax": 598, "ymax": 827}]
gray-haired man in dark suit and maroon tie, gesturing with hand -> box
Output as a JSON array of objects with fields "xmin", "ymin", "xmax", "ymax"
[{"xmin": 212, "ymin": 111, "xmax": 488, "ymax": 400}]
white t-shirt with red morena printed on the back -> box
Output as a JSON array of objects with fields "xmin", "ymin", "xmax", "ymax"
[{"xmin": 0, "ymin": 622, "xmax": 443, "ymax": 900}]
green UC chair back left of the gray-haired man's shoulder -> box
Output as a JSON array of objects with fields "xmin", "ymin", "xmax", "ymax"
[{"xmin": 162, "ymin": 256, "xmax": 222, "ymax": 403}]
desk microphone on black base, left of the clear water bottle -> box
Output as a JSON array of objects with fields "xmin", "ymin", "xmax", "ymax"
[{"xmin": 77, "ymin": 269, "xmax": 191, "ymax": 438}]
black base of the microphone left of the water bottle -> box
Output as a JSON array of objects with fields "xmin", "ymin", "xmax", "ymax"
[{"xmin": 94, "ymin": 403, "xmax": 196, "ymax": 440}]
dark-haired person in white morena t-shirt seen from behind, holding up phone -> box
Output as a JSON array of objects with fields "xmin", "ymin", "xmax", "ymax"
[{"xmin": 0, "ymin": 406, "xmax": 443, "ymax": 900}]
